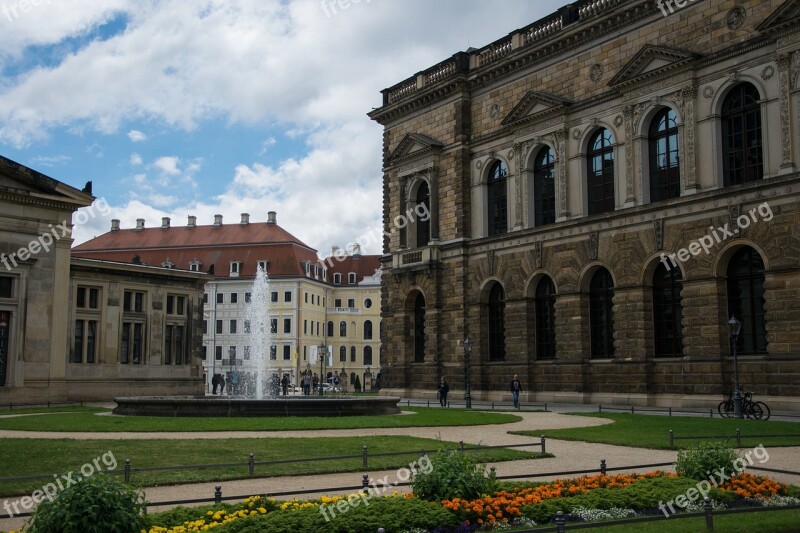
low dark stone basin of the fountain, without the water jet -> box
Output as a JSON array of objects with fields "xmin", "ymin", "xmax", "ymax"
[{"xmin": 113, "ymin": 396, "xmax": 400, "ymax": 417}]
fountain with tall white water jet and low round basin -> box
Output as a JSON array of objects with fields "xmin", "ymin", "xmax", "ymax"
[{"xmin": 113, "ymin": 267, "xmax": 400, "ymax": 417}]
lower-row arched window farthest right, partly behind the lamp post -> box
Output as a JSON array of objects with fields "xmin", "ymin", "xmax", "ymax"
[{"xmin": 728, "ymin": 247, "xmax": 767, "ymax": 354}]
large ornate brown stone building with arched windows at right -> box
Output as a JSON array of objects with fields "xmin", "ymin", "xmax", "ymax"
[{"xmin": 369, "ymin": 0, "xmax": 800, "ymax": 409}]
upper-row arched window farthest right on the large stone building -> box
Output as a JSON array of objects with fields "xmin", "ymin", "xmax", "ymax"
[{"xmin": 722, "ymin": 83, "xmax": 764, "ymax": 187}]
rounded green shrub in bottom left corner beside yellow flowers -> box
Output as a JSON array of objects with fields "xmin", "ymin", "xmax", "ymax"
[{"xmin": 26, "ymin": 475, "xmax": 147, "ymax": 533}]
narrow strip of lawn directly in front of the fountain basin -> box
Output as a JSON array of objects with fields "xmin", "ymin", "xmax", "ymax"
[{"xmin": 0, "ymin": 407, "xmax": 521, "ymax": 432}]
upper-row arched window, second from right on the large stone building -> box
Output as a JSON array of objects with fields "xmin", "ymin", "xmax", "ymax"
[{"xmin": 650, "ymin": 108, "xmax": 681, "ymax": 202}]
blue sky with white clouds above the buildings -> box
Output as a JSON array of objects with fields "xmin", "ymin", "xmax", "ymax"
[{"xmin": 0, "ymin": 0, "xmax": 566, "ymax": 257}]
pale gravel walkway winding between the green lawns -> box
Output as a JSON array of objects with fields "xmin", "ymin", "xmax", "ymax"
[{"xmin": 0, "ymin": 412, "xmax": 800, "ymax": 530}]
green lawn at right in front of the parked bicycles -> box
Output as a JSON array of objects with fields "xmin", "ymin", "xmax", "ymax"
[{"xmin": 512, "ymin": 413, "xmax": 800, "ymax": 449}]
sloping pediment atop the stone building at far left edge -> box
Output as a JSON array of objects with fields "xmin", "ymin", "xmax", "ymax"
[{"xmin": 0, "ymin": 156, "xmax": 94, "ymax": 206}]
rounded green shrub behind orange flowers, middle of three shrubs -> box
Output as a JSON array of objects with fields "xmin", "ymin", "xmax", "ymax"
[{"xmin": 412, "ymin": 449, "xmax": 497, "ymax": 501}]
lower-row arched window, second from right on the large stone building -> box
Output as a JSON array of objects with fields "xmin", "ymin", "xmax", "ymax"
[{"xmin": 653, "ymin": 263, "xmax": 683, "ymax": 357}]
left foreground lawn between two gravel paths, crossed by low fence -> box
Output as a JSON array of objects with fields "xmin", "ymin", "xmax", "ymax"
[{"xmin": 0, "ymin": 436, "xmax": 551, "ymax": 496}]
